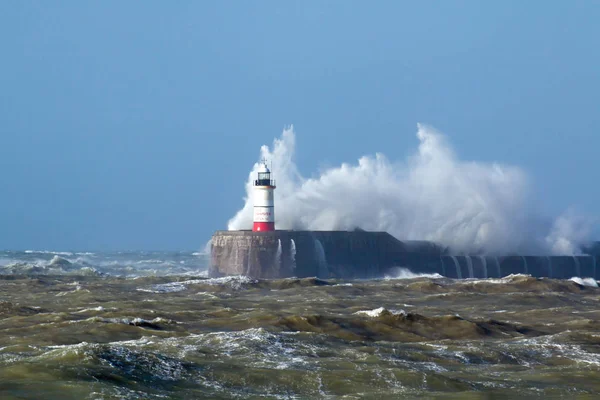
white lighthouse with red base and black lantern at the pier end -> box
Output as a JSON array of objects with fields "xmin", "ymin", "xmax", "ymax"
[{"xmin": 252, "ymin": 159, "xmax": 275, "ymax": 232}]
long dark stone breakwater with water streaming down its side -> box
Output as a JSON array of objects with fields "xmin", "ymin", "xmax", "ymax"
[{"xmin": 209, "ymin": 230, "xmax": 600, "ymax": 279}]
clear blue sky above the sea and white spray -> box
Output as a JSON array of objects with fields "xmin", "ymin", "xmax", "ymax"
[{"xmin": 0, "ymin": 1, "xmax": 600, "ymax": 250}]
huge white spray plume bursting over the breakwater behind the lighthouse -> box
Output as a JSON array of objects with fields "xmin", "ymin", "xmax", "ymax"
[{"xmin": 228, "ymin": 124, "xmax": 589, "ymax": 254}]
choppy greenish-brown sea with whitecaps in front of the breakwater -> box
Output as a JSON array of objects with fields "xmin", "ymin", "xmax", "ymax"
[{"xmin": 0, "ymin": 251, "xmax": 600, "ymax": 399}]
